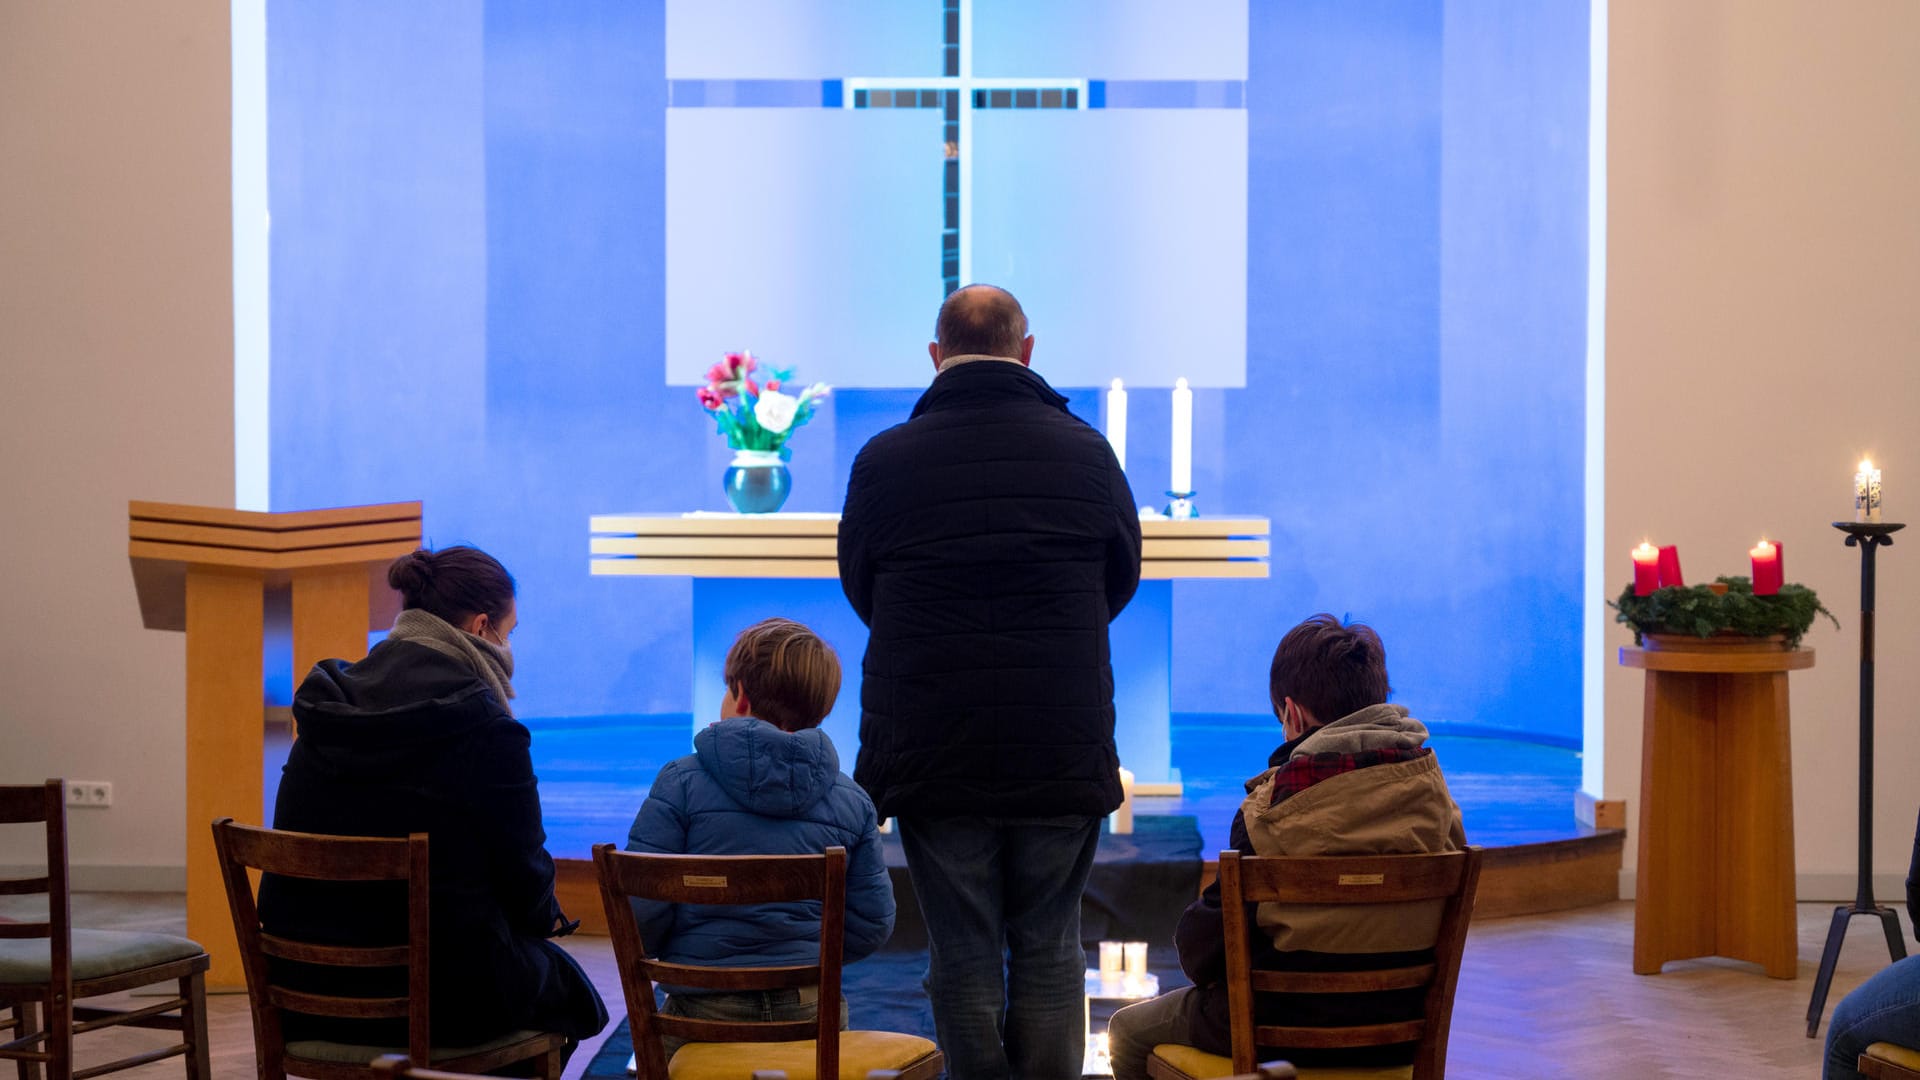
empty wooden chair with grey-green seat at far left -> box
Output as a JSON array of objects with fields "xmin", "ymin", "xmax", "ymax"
[{"xmin": 0, "ymin": 780, "xmax": 211, "ymax": 1080}]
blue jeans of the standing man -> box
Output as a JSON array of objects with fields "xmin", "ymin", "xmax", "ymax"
[{"xmin": 900, "ymin": 817, "xmax": 1100, "ymax": 1080}]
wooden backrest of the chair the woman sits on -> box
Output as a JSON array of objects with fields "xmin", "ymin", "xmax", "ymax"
[{"xmin": 213, "ymin": 817, "xmax": 432, "ymax": 1076}]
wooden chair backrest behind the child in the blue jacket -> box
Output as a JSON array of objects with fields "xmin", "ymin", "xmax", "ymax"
[{"xmin": 593, "ymin": 844, "xmax": 847, "ymax": 1080}]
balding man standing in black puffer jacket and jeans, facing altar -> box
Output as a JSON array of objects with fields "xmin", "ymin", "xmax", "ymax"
[{"xmin": 839, "ymin": 284, "xmax": 1140, "ymax": 1080}]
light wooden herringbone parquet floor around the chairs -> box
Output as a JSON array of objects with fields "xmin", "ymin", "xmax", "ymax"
[{"xmin": 33, "ymin": 894, "xmax": 1912, "ymax": 1080}]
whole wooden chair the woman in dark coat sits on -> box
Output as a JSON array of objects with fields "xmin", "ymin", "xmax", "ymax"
[{"xmin": 213, "ymin": 817, "xmax": 566, "ymax": 1080}]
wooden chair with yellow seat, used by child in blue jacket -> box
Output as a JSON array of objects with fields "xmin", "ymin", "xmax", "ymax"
[{"xmin": 593, "ymin": 844, "xmax": 945, "ymax": 1080}]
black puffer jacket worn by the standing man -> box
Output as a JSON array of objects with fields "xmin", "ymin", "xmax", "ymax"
[{"xmin": 839, "ymin": 359, "xmax": 1140, "ymax": 819}]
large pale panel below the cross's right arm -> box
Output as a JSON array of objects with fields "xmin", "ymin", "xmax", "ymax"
[{"xmin": 973, "ymin": 110, "xmax": 1246, "ymax": 386}]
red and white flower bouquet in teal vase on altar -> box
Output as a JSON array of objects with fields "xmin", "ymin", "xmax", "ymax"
[{"xmin": 695, "ymin": 352, "xmax": 829, "ymax": 513}]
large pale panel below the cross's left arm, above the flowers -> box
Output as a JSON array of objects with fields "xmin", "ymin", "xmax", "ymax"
[{"xmin": 666, "ymin": 110, "xmax": 945, "ymax": 388}]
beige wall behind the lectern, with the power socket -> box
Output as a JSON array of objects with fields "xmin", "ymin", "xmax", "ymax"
[{"xmin": 0, "ymin": 0, "xmax": 232, "ymax": 886}]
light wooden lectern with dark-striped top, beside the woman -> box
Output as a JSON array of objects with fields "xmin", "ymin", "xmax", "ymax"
[{"xmin": 127, "ymin": 502, "xmax": 420, "ymax": 988}]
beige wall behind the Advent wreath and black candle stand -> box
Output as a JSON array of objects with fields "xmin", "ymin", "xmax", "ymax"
[{"xmin": 1605, "ymin": 0, "xmax": 1920, "ymax": 901}]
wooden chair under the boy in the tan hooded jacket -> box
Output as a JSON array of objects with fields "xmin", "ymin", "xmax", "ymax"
[{"xmin": 1146, "ymin": 847, "xmax": 1480, "ymax": 1080}]
